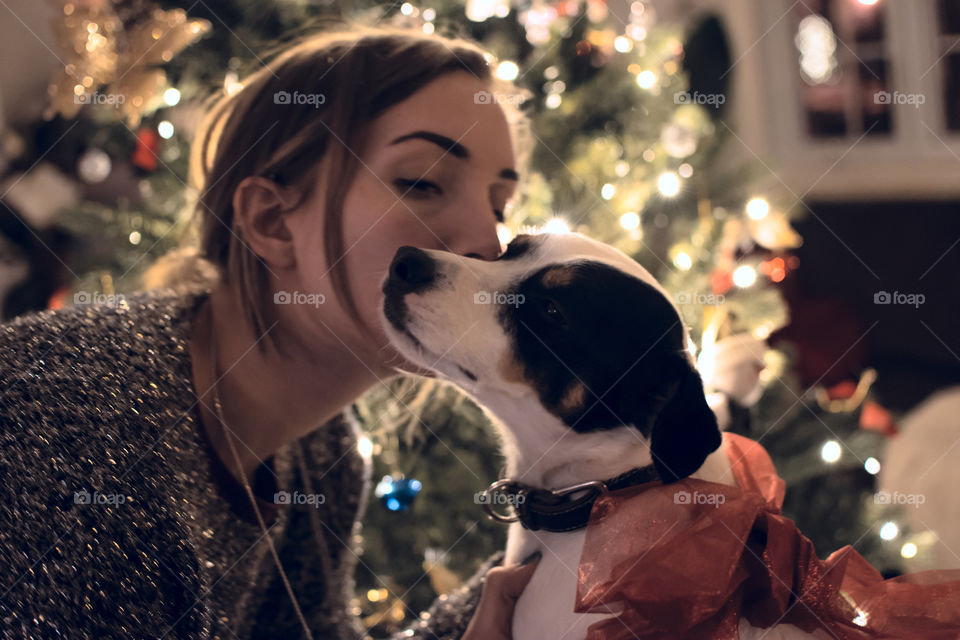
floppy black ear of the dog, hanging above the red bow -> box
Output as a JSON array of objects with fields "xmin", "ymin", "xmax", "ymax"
[{"xmin": 650, "ymin": 354, "xmax": 721, "ymax": 483}]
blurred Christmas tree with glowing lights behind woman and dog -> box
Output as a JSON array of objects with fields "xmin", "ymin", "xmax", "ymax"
[{"xmin": 4, "ymin": 0, "xmax": 925, "ymax": 637}]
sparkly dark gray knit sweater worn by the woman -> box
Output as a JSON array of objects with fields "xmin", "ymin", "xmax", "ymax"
[{"xmin": 0, "ymin": 291, "xmax": 499, "ymax": 640}]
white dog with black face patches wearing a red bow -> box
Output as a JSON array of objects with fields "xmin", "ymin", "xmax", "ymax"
[{"xmin": 381, "ymin": 233, "xmax": 814, "ymax": 640}]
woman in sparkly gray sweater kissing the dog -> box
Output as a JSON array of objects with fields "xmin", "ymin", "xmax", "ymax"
[{"xmin": 0, "ymin": 30, "xmax": 536, "ymax": 639}]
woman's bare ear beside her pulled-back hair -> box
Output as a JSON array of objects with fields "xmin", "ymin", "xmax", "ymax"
[{"xmin": 233, "ymin": 176, "xmax": 296, "ymax": 269}]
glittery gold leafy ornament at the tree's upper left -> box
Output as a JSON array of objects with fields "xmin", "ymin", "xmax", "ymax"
[{"xmin": 44, "ymin": 2, "xmax": 210, "ymax": 127}]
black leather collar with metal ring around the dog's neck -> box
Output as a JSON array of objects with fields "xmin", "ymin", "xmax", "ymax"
[{"xmin": 481, "ymin": 464, "xmax": 660, "ymax": 532}]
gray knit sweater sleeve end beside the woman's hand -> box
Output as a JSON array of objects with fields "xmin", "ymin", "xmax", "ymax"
[{"xmin": 391, "ymin": 551, "xmax": 504, "ymax": 640}]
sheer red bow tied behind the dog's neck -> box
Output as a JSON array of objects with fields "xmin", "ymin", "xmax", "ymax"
[{"xmin": 575, "ymin": 433, "xmax": 960, "ymax": 640}]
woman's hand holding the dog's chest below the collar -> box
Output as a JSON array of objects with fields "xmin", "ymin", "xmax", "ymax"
[{"xmin": 462, "ymin": 551, "xmax": 541, "ymax": 640}]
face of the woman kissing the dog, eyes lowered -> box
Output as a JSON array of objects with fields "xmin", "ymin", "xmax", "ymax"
[{"xmin": 289, "ymin": 72, "xmax": 517, "ymax": 371}]
